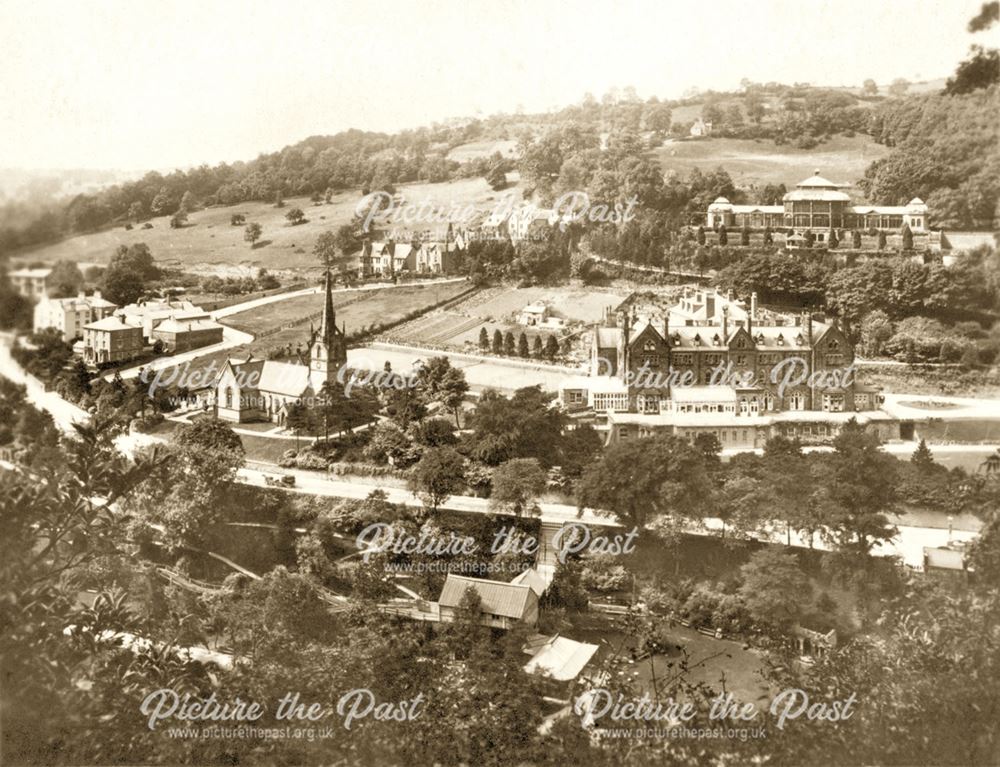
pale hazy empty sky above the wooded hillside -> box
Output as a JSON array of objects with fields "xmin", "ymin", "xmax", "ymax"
[{"xmin": 0, "ymin": 0, "xmax": 992, "ymax": 169}]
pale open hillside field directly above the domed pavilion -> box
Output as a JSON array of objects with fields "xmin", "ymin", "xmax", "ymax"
[{"xmin": 654, "ymin": 135, "xmax": 889, "ymax": 187}]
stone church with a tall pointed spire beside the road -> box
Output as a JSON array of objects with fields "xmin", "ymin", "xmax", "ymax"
[{"xmin": 213, "ymin": 272, "xmax": 347, "ymax": 424}]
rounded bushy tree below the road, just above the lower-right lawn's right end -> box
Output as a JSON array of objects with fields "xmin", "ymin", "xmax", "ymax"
[{"xmin": 739, "ymin": 546, "xmax": 812, "ymax": 629}]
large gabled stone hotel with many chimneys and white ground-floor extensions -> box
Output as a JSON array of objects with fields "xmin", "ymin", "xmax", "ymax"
[{"xmin": 560, "ymin": 289, "xmax": 891, "ymax": 448}]
